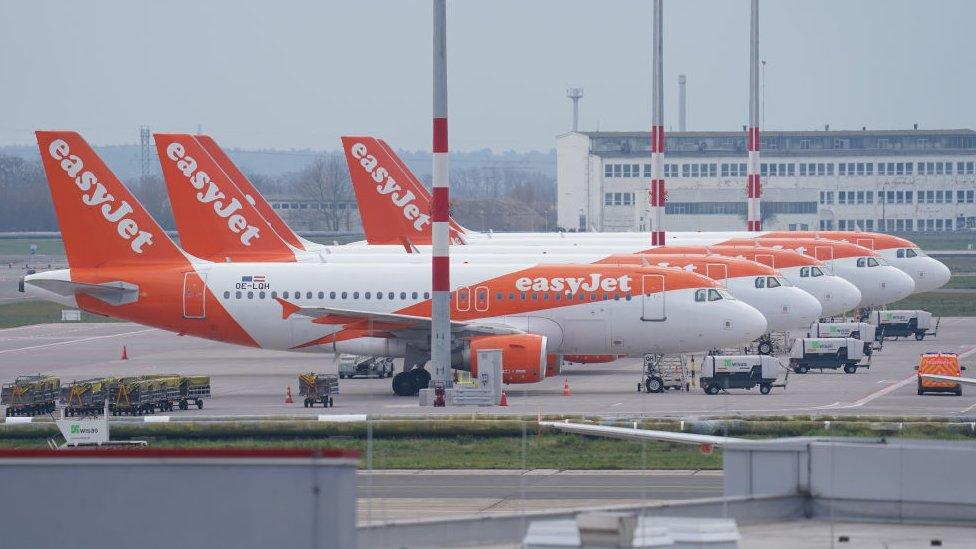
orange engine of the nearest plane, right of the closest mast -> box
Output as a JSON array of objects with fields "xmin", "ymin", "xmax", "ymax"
[{"xmin": 464, "ymin": 334, "xmax": 546, "ymax": 383}]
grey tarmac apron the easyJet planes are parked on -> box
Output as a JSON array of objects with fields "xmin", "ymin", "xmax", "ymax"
[{"xmin": 0, "ymin": 318, "xmax": 976, "ymax": 417}]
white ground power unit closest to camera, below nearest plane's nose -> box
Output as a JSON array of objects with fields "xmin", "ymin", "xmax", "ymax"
[{"xmin": 701, "ymin": 355, "xmax": 786, "ymax": 395}]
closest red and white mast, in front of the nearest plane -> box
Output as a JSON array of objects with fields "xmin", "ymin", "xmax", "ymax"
[{"xmin": 430, "ymin": 0, "xmax": 452, "ymax": 387}]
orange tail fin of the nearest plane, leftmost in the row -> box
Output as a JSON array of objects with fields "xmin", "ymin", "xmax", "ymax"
[{"xmin": 35, "ymin": 131, "xmax": 187, "ymax": 268}]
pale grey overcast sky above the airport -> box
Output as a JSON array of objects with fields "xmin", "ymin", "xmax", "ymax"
[{"xmin": 0, "ymin": 0, "xmax": 976, "ymax": 151}]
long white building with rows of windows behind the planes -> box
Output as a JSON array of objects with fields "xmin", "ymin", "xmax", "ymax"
[{"xmin": 556, "ymin": 129, "xmax": 976, "ymax": 233}]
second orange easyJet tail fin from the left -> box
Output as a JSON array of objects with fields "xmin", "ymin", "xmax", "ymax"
[{"xmin": 153, "ymin": 134, "xmax": 295, "ymax": 261}]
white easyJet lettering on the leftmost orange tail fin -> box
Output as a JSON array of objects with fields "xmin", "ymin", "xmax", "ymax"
[{"xmin": 47, "ymin": 139, "xmax": 152, "ymax": 254}]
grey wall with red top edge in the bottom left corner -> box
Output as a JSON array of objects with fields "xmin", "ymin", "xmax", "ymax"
[{"xmin": 0, "ymin": 450, "xmax": 356, "ymax": 549}]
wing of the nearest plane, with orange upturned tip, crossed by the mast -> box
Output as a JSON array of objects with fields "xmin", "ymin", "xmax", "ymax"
[{"xmin": 275, "ymin": 297, "xmax": 524, "ymax": 335}]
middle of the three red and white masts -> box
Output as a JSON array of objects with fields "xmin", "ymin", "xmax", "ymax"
[{"xmin": 648, "ymin": 0, "xmax": 667, "ymax": 246}]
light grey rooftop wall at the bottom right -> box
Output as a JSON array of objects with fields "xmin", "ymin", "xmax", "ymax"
[{"xmin": 723, "ymin": 439, "xmax": 976, "ymax": 522}]
